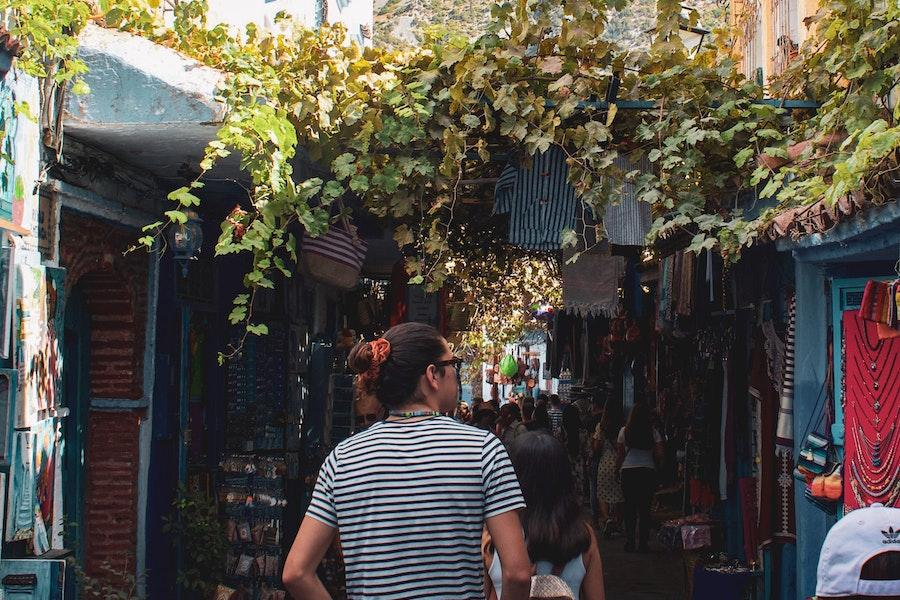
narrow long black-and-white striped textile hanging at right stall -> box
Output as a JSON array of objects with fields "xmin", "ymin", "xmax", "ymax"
[{"xmin": 774, "ymin": 297, "xmax": 797, "ymax": 538}]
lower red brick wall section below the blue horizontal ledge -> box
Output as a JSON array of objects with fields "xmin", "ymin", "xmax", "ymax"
[{"xmin": 84, "ymin": 410, "xmax": 142, "ymax": 575}]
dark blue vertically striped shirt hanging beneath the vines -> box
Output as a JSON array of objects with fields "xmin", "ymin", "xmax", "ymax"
[{"xmin": 494, "ymin": 146, "xmax": 578, "ymax": 250}]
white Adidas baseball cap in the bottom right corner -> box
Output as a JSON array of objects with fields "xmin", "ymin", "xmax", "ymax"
[{"xmin": 816, "ymin": 504, "xmax": 900, "ymax": 598}]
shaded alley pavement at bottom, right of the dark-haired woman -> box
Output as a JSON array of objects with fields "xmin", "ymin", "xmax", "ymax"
[{"xmin": 599, "ymin": 536, "xmax": 684, "ymax": 600}]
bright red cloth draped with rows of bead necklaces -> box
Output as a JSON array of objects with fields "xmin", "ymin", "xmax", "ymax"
[{"xmin": 843, "ymin": 311, "xmax": 900, "ymax": 511}]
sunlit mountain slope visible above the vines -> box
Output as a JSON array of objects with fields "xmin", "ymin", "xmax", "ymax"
[{"xmin": 375, "ymin": 0, "xmax": 726, "ymax": 50}]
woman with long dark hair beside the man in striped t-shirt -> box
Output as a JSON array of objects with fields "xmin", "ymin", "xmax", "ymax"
[{"xmin": 482, "ymin": 431, "xmax": 605, "ymax": 600}]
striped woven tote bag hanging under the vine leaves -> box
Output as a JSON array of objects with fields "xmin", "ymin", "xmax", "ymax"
[{"xmin": 300, "ymin": 200, "xmax": 368, "ymax": 290}]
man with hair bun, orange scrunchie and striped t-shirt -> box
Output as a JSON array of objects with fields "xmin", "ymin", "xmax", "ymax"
[{"xmin": 283, "ymin": 323, "xmax": 531, "ymax": 600}]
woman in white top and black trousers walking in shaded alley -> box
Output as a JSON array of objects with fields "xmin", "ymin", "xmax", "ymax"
[{"xmin": 617, "ymin": 402, "xmax": 663, "ymax": 552}]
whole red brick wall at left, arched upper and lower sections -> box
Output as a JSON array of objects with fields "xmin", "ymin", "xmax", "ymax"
[{"xmin": 59, "ymin": 211, "xmax": 148, "ymax": 575}]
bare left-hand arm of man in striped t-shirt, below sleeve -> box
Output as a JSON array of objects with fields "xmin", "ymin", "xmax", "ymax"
[{"xmin": 282, "ymin": 517, "xmax": 337, "ymax": 600}]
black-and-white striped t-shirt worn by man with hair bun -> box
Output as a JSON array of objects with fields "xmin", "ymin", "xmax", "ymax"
[{"xmin": 307, "ymin": 417, "xmax": 525, "ymax": 600}]
